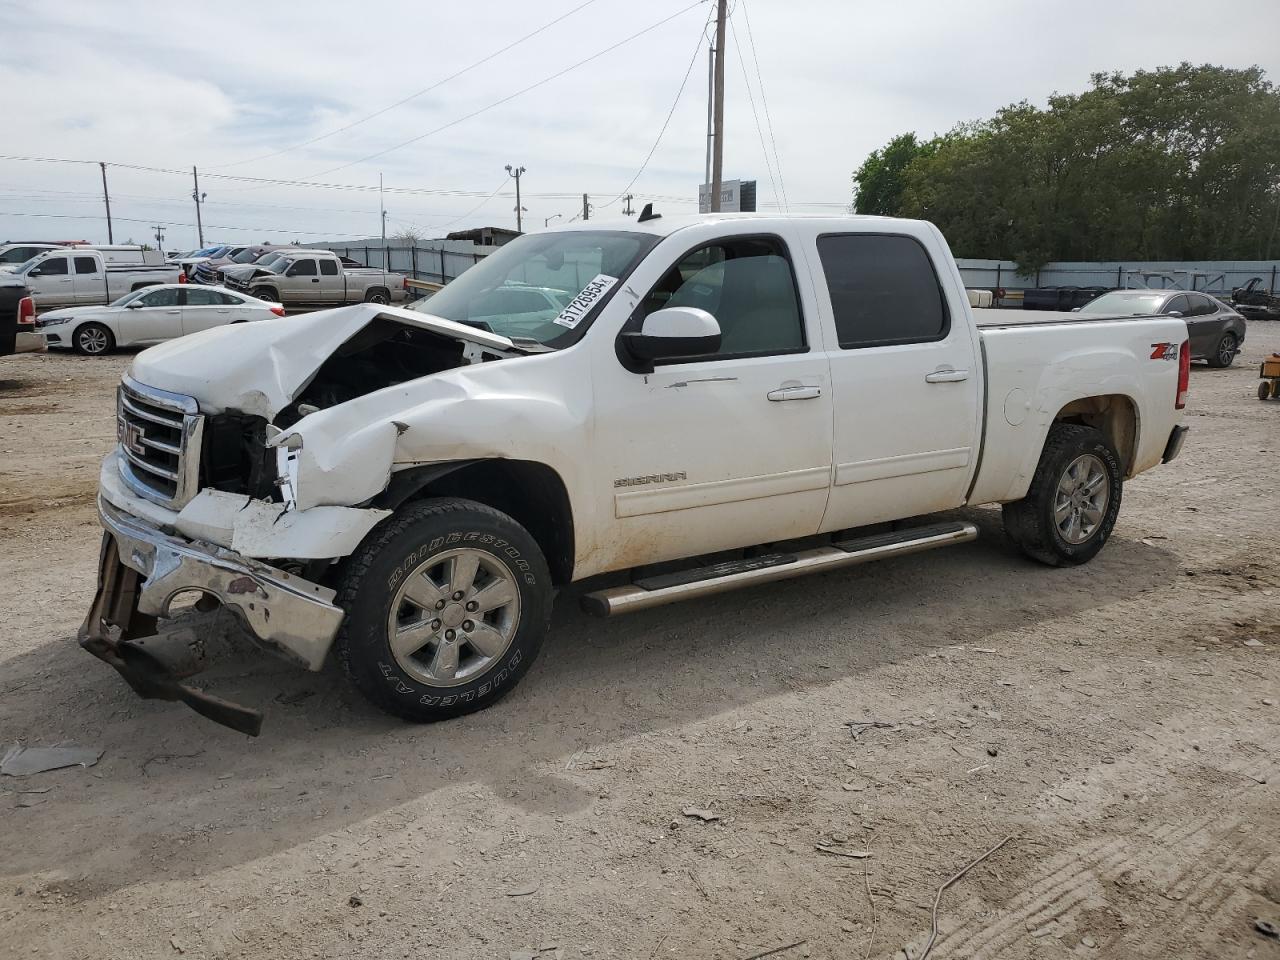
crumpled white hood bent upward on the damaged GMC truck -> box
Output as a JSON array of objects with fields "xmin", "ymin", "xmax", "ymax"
[{"xmin": 131, "ymin": 303, "xmax": 513, "ymax": 420}]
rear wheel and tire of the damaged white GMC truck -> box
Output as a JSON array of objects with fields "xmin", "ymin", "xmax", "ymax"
[{"xmin": 1004, "ymin": 424, "xmax": 1124, "ymax": 567}]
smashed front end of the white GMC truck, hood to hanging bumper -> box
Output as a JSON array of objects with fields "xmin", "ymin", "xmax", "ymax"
[{"xmin": 79, "ymin": 305, "xmax": 518, "ymax": 736}]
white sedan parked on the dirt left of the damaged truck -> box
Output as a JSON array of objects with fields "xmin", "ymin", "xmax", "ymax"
[{"xmin": 36, "ymin": 283, "xmax": 284, "ymax": 355}]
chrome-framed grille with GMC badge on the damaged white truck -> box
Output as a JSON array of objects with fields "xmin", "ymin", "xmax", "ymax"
[{"xmin": 115, "ymin": 376, "xmax": 205, "ymax": 509}]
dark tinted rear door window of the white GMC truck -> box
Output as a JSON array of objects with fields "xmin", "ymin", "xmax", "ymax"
[{"xmin": 818, "ymin": 233, "xmax": 951, "ymax": 349}]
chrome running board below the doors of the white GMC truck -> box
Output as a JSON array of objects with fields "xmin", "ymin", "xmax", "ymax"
[{"xmin": 582, "ymin": 522, "xmax": 978, "ymax": 617}]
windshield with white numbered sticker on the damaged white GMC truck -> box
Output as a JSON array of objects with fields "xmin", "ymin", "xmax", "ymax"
[{"xmin": 410, "ymin": 230, "xmax": 659, "ymax": 348}]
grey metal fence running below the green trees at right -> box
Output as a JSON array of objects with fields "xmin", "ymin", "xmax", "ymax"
[{"xmin": 956, "ymin": 259, "xmax": 1280, "ymax": 294}]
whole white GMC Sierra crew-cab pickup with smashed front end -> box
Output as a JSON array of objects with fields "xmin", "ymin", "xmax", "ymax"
[{"xmin": 81, "ymin": 215, "xmax": 1189, "ymax": 733}]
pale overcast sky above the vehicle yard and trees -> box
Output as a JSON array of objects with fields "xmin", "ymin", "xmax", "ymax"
[{"xmin": 0, "ymin": 0, "xmax": 1280, "ymax": 248}]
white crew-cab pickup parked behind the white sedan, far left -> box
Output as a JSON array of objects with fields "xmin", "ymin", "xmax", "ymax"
[{"xmin": 12, "ymin": 247, "xmax": 180, "ymax": 310}]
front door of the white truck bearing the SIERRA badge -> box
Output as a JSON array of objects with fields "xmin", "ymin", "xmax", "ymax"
[{"xmin": 591, "ymin": 221, "xmax": 832, "ymax": 570}]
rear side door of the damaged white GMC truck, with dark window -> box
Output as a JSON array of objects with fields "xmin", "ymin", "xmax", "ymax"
[{"xmin": 806, "ymin": 231, "xmax": 983, "ymax": 531}]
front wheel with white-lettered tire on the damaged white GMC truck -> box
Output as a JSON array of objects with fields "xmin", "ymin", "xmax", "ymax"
[{"xmin": 337, "ymin": 498, "xmax": 552, "ymax": 722}]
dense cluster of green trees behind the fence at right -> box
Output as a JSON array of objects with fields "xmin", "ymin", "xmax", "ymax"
[{"xmin": 855, "ymin": 63, "xmax": 1280, "ymax": 271}]
